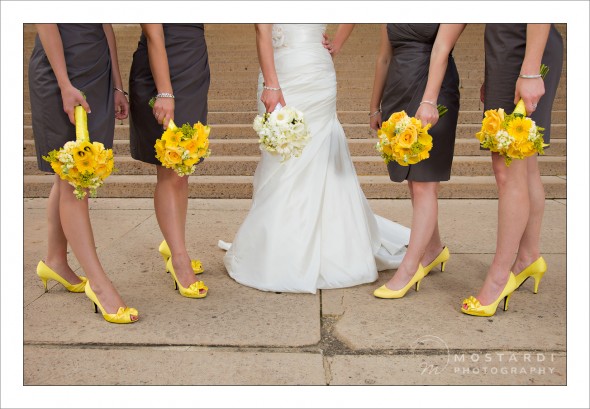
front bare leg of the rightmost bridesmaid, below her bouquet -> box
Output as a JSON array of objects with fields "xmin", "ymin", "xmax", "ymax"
[{"xmin": 477, "ymin": 153, "xmax": 529, "ymax": 305}]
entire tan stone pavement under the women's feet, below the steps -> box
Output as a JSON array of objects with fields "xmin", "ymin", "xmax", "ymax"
[{"xmin": 23, "ymin": 198, "xmax": 577, "ymax": 396}]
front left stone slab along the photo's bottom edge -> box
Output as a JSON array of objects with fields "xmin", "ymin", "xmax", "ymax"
[{"xmin": 24, "ymin": 346, "xmax": 326, "ymax": 384}]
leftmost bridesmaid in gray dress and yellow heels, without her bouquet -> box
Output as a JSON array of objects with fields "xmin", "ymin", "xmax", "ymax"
[{"xmin": 29, "ymin": 24, "xmax": 138, "ymax": 324}]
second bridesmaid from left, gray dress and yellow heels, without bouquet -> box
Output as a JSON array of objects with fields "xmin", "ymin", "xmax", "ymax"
[{"xmin": 129, "ymin": 24, "xmax": 210, "ymax": 298}]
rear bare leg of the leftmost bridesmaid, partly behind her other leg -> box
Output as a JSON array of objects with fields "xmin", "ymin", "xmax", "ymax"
[{"xmin": 45, "ymin": 175, "xmax": 80, "ymax": 284}]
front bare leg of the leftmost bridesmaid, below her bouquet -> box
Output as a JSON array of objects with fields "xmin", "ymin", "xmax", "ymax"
[{"xmin": 59, "ymin": 180, "xmax": 133, "ymax": 319}]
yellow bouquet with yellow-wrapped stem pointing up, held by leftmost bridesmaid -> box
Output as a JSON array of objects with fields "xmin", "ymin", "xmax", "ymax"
[{"xmin": 43, "ymin": 105, "xmax": 115, "ymax": 200}]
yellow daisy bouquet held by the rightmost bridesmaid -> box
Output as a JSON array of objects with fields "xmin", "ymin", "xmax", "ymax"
[{"xmin": 475, "ymin": 65, "xmax": 549, "ymax": 166}]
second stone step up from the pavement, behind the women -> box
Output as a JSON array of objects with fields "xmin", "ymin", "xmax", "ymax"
[{"xmin": 24, "ymin": 155, "xmax": 567, "ymax": 176}]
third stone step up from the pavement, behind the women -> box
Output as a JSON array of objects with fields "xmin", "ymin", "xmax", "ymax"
[{"xmin": 24, "ymin": 138, "xmax": 567, "ymax": 156}]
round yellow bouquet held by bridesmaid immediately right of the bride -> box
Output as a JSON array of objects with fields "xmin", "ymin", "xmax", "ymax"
[{"xmin": 375, "ymin": 109, "xmax": 440, "ymax": 166}]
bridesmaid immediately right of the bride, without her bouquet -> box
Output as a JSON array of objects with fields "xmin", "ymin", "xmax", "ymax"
[{"xmin": 369, "ymin": 24, "xmax": 465, "ymax": 298}]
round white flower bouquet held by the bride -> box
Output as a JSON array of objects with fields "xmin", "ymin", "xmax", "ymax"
[{"xmin": 253, "ymin": 104, "xmax": 310, "ymax": 162}]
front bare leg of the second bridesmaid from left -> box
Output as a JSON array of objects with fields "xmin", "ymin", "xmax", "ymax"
[{"xmin": 154, "ymin": 166, "xmax": 204, "ymax": 287}]
